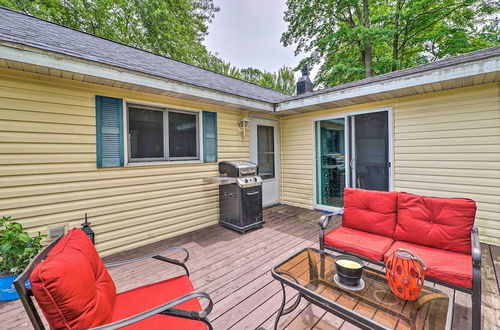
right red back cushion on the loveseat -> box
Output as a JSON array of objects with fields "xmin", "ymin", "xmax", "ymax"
[{"xmin": 394, "ymin": 193, "xmax": 476, "ymax": 254}]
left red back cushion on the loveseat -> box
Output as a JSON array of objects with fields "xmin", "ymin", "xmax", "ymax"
[{"xmin": 342, "ymin": 188, "xmax": 398, "ymax": 238}]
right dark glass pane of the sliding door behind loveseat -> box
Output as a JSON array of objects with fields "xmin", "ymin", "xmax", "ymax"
[{"xmin": 354, "ymin": 111, "xmax": 389, "ymax": 191}]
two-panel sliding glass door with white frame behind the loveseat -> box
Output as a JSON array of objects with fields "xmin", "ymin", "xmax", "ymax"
[{"xmin": 315, "ymin": 111, "xmax": 391, "ymax": 208}]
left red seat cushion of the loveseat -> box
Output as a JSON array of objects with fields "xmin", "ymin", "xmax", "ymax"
[{"xmin": 324, "ymin": 226, "xmax": 394, "ymax": 261}]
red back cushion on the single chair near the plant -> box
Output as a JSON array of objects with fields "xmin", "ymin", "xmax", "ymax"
[{"xmin": 30, "ymin": 228, "xmax": 116, "ymax": 329}]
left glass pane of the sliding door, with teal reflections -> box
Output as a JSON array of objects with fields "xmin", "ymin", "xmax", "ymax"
[{"xmin": 316, "ymin": 118, "xmax": 345, "ymax": 207}]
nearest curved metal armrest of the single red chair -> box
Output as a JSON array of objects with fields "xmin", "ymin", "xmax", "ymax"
[{"xmin": 92, "ymin": 292, "xmax": 213, "ymax": 330}]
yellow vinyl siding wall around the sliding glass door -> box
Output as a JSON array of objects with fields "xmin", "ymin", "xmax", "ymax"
[{"xmin": 281, "ymin": 83, "xmax": 500, "ymax": 245}]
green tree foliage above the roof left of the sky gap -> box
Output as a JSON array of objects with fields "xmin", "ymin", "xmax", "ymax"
[{"xmin": 0, "ymin": 0, "xmax": 294, "ymax": 94}]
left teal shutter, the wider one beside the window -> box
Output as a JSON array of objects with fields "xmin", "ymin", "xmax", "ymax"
[{"xmin": 96, "ymin": 96, "xmax": 124, "ymax": 168}]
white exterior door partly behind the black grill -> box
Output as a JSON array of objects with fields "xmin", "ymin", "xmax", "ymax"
[{"xmin": 250, "ymin": 118, "xmax": 280, "ymax": 206}]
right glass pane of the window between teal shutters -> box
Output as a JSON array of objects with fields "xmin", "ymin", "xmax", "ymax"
[{"xmin": 168, "ymin": 111, "xmax": 198, "ymax": 158}]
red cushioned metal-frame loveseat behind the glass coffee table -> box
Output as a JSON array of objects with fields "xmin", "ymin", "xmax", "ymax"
[{"xmin": 319, "ymin": 188, "xmax": 481, "ymax": 329}]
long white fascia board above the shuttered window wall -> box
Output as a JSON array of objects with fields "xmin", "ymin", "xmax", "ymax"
[{"xmin": 0, "ymin": 44, "xmax": 274, "ymax": 112}]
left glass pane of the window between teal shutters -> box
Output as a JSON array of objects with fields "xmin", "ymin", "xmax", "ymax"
[{"xmin": 128, "ymin": 108, "xmax": 164, "ymax": 158}]
